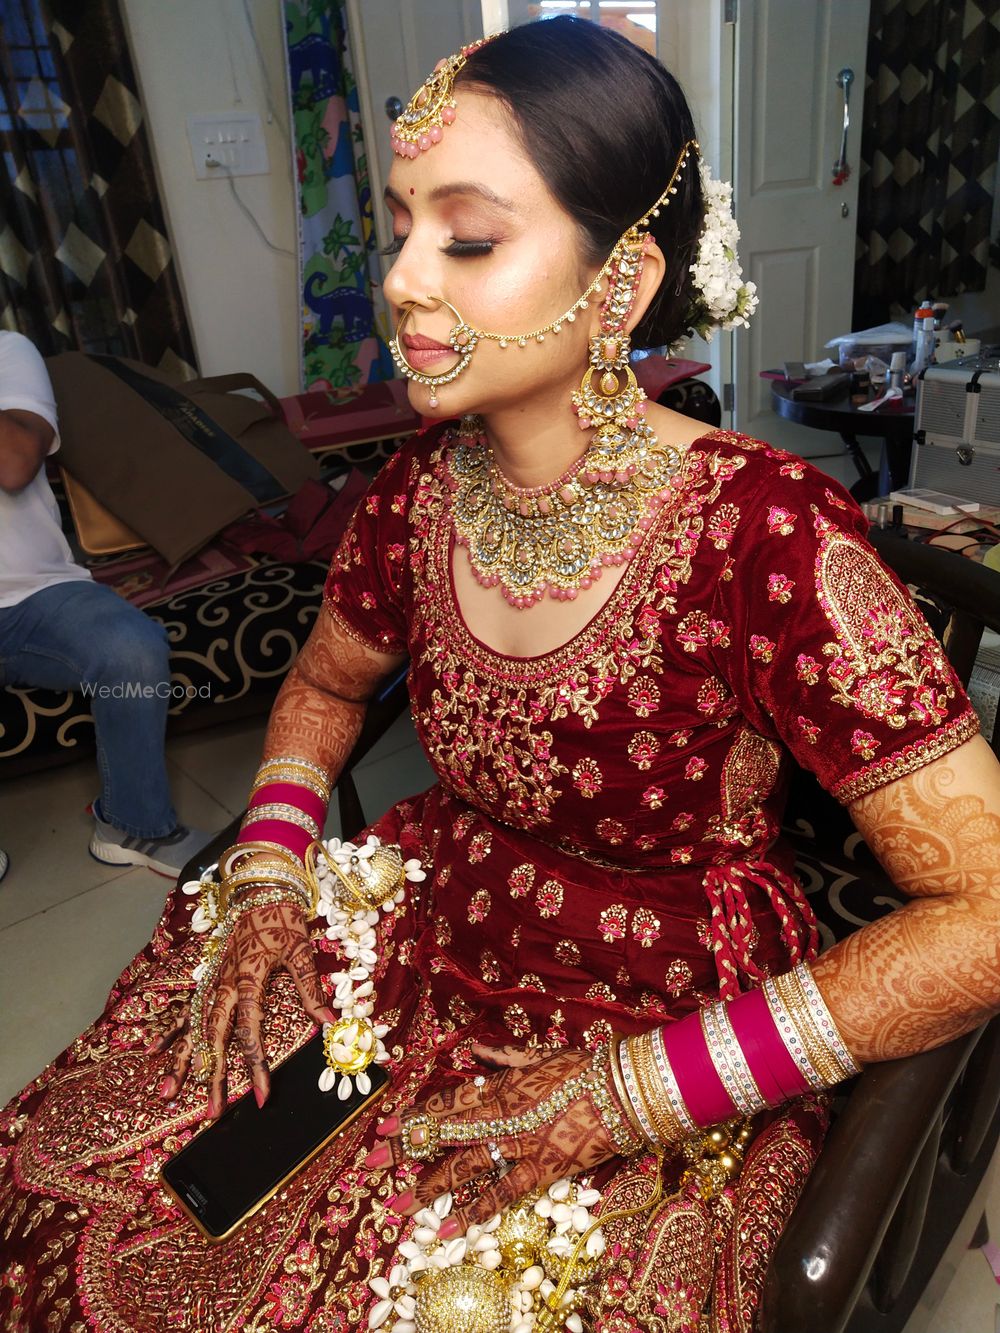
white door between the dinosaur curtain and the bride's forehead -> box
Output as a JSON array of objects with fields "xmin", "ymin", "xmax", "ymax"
[{"xmin": 347, "ymin": 0, "xmax": 483, "ymax": 264}]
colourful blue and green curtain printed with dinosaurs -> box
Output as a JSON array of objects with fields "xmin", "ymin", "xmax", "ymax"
[{"xmin": 284, "ymin": 0, "xmax": 393, "ymax": 389}]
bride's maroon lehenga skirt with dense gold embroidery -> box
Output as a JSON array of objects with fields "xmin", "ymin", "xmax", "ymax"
[{"xmin": 0, "ymin": 788, "xmax": 824, "ymax": 1333}]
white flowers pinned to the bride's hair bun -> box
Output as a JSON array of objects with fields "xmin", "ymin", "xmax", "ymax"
[{"xmin": 688, "ymin": 160, "xmax": 759, "ymax": 343}]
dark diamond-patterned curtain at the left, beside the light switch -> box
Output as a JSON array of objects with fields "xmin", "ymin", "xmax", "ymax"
[{"xmin": 0, "ymin": 0, "xmax": 196, "ymax": 377}]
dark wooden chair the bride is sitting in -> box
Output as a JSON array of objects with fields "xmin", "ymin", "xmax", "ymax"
[{"xmin": 760, "ymin": 532, "xmax": 1000, "ymax": 1333}]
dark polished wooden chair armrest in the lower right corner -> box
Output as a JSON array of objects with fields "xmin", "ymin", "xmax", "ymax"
[{"xmin": 760, "ymin": 1029, "xmax": 981, "ymax": 1333}]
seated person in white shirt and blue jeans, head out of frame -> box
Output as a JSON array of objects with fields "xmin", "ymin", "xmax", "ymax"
[{"xmin": 0, "ymin": 331, "xmax": 208, "ymax": 876}]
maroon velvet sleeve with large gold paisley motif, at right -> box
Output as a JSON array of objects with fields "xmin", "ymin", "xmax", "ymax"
[{"xmin": 717, "ymin": 469, "xmax": 979, "ymax": 805}]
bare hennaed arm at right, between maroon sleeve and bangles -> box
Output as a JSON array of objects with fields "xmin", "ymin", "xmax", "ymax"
[{"xmin": 812, "ymin": 737, "xmax": 1000, "ymax": 1064}]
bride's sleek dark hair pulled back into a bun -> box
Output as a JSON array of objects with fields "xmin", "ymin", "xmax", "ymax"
[{"xmin": 456, "ymin": 16, "xmax": 704, "ymax": 347}]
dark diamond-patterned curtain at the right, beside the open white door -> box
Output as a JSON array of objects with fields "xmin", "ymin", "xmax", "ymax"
[{"xmin": 855, "ymin": 0, "xmax": 1000, "ymax": 328}]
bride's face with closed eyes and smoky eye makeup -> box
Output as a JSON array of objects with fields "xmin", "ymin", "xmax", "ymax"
[{"xmin": 385, "ymin": 89, "xmax": 607, "ymax": 419}]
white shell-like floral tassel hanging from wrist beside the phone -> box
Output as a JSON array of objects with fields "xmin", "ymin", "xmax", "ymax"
[{"xmin": 316, "ymin": 834, "xmax": 427, "ymax": 1100}]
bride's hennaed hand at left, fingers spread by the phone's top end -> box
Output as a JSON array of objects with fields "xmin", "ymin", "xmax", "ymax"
[{"xmin": 149, "ymin": 900, "xmax": 335, "ymax": 1120}]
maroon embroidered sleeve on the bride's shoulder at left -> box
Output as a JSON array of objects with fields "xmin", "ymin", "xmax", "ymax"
[{"xmin": 323, "ymin": 445, "xmax": 419, "ymax": 653}]
